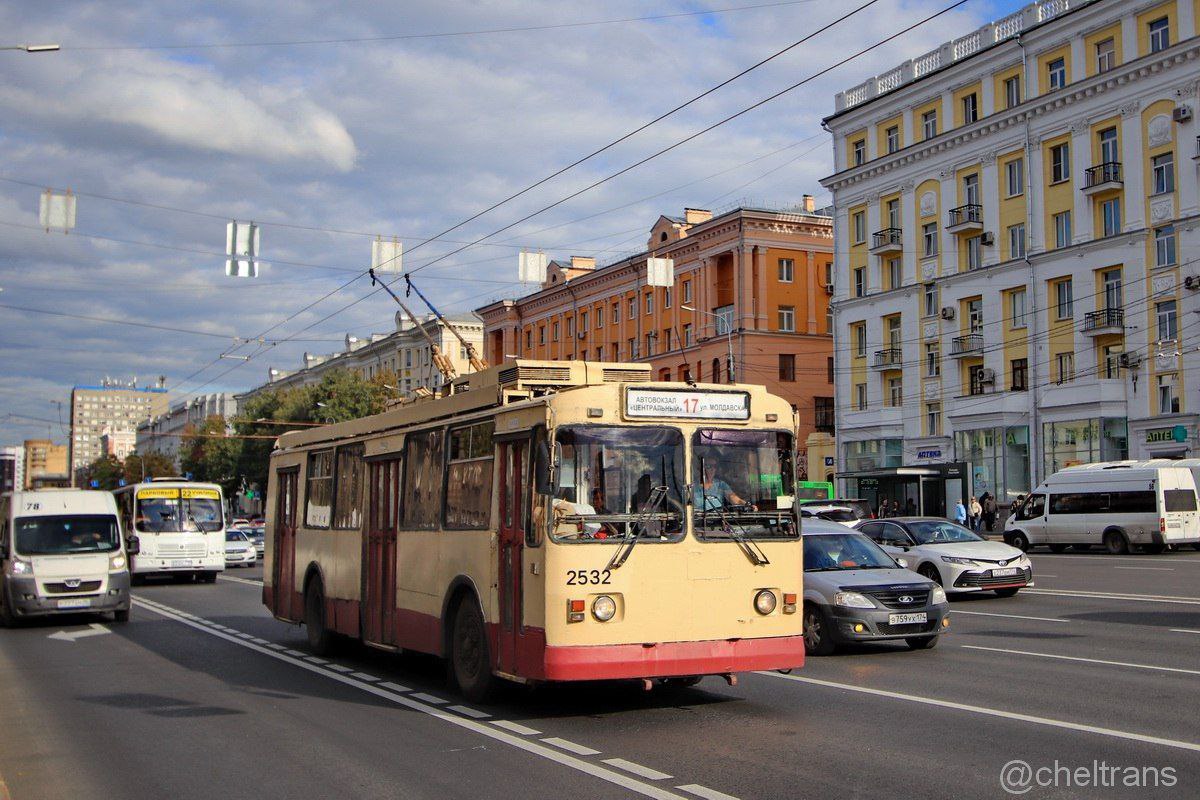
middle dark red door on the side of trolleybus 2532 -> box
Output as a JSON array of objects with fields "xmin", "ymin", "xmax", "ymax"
[{"xmin": 362, "ymin": 458, "xmax": 400, "ymax": 646}]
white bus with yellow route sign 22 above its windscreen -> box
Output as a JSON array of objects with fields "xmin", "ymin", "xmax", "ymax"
[{"xmin": 113, "ymin": 477, "xmax": 226, "ymax": 583}]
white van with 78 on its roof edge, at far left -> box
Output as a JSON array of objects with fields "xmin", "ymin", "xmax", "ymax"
[{"xmin": 0, "ymin": 489, "xmax": 138, "ymax": 626}]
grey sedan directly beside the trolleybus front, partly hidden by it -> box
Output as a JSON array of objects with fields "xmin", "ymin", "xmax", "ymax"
[{"xmin": 800, "ymin": 518, "xmax": 950, "ymax": 656}]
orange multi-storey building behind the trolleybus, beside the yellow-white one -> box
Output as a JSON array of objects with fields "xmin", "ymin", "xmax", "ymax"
[{"xmin": 476, "ymin": 205, "xmax": 833, "ymax": 479}]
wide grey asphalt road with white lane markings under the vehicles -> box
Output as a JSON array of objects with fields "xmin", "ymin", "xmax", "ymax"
[{"xmin": 0, "ymin": 552, "xmax": 1200, "ymax": 800}]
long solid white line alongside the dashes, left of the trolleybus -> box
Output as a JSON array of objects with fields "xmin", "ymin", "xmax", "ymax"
[{"xmin": 133, "ymin": 597, "xmax": 686, "ymax": 800}]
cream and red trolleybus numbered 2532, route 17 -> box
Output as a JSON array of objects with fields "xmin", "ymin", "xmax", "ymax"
[{"xmin": 263, "ymin": 360, "xmax": 804, "ymax": 699}]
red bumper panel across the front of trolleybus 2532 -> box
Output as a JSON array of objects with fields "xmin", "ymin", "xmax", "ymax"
[{"xmin": 545, "ymin": 636, "xmax": 804, "ymax": 680}]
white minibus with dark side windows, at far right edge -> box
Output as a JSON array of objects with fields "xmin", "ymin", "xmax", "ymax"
[{"xmin": 1004, "ymin": 462, "xmax": 1200, "ymax": 553}]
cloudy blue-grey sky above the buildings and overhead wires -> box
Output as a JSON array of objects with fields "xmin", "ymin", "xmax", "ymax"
[{"xmin": 0, "ymin": 0, "xmax": 1019, "ymax": 444}]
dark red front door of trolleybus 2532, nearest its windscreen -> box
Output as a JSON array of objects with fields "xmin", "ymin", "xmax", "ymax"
[{"xmin": 497, "ymin": 440, "xmax": 529, "ymax": 674}]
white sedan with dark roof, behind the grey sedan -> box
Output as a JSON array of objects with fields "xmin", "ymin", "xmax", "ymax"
[{"xmin": 854, "ymin": 517, "xmax": 1033, "ymax": 597}]
